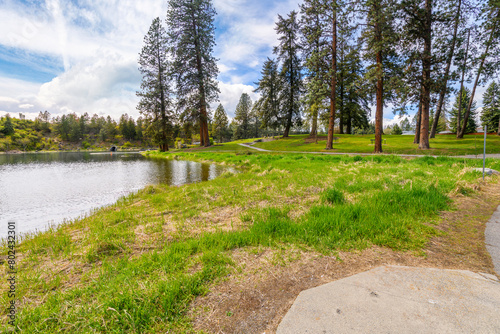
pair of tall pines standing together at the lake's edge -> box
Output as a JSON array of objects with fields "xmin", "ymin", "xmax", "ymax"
[{"xmin": 137, "ymin": 0, "xmax": 219, "ymax": 151}]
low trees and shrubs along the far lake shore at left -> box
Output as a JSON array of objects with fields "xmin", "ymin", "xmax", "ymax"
[{"xmin": 0, "ymin": 111, "xmax": 152, "ymax": 151}]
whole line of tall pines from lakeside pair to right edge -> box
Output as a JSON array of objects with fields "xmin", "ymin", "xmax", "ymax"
[{"xmin": 138, "ymin": 0, "xmax": 500, "ymax": 152}]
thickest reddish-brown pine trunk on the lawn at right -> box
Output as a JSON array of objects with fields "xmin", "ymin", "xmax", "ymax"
[{"xmin": 418, "ymin": 0, "xmax": 432, "ymax": 150}]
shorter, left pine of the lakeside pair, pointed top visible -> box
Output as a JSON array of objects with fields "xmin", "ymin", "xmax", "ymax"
[{"xmin": 137, "ymin": 18, "xmax": 174, "ymax": 152}]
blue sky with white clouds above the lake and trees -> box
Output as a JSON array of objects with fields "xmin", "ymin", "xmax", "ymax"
[{"xmin": 0, "ymin": 0, "xmax": 488, "ymax": 124}]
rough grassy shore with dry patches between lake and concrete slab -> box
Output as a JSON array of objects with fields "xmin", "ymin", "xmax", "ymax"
[{"xmin": 0, "ymin": 151, "xmax": 500, "ymax": 333}]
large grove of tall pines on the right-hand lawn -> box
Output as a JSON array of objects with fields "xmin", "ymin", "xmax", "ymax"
[{"xmin": 252, "ymin": 0, "xmax": 500, "ymax": 152}]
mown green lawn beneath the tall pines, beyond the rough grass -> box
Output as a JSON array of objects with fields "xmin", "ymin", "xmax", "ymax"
[{"xmin": 245, "ymin": 134, "xmax": 500, "ymax": 155}]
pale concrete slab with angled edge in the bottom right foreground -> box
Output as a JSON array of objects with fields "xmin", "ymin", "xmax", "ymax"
[{"xmin": 277, "ymin": 266, "xmax": 500, "ymax": 334}]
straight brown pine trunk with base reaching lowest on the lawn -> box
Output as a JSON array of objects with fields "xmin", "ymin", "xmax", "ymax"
[{"xmin": 373, "ymin": 1, "xmax": 384, "ymax": 153}]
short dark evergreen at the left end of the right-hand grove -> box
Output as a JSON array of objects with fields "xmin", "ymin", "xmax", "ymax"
[{"xmin": 255, "ymin": 58, "xmax": 282, "ymax": 131}]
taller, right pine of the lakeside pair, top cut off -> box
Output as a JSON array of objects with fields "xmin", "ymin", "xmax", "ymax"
[{"xmin": 167, "ymin": 0, "xmax": 219, "ymax": 146}]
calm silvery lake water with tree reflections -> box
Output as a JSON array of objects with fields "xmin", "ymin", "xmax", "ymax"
[{"xmin": 0, "ymin": 152, "xmax": 234, "ymax": 238}]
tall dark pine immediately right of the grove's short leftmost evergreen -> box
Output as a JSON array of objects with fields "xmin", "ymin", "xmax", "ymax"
[{"xmin": 274, "ymin": 11, "xmax": 302, "ymax": 138}]
